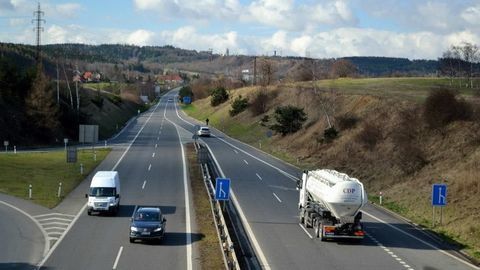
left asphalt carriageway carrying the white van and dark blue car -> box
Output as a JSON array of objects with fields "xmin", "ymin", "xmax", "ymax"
[{"xmin": 42, "ymin": 94, "xmax": 196, "ymax": 269}]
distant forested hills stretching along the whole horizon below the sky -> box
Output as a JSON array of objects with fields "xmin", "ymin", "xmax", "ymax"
[{"xmin": 0, "ymin": 43, "xmax": 438, "ymax": 77}]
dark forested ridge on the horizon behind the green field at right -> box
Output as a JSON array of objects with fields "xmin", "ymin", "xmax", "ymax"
[{"xmin": 343, "ymin": 56, "xmax": 438, "ymax": 77}]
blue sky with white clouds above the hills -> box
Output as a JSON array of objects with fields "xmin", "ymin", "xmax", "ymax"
[{"xmin": 0, "ymin": 0, "xmax": 480, "ymax": 59}]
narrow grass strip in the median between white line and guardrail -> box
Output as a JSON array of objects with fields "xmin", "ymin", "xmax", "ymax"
[{"xmin": 187, "ymin": 144, "xmax": 225, "ymax": 269}]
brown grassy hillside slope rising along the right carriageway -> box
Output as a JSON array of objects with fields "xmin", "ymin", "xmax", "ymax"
[{"xmin": 184, "ymin": 78, "xmax": 480, "ymax": 258}]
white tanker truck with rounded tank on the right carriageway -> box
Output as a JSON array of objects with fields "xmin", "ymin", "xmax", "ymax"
[{"xmin": 297, "ymin": 170, "xmax": 367, "ymax": 241}]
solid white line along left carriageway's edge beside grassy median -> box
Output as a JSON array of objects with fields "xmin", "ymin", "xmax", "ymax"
[{"xmin": 163, "ymin": 95, "xmax": 193, "ymax": 270}]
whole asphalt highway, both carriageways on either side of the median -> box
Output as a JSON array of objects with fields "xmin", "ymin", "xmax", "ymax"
[{"xmin": 0, "ymin": 91, "xmax": 480, "ymax": 270}]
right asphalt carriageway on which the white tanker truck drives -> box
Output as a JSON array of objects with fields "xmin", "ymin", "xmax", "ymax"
[{"xmin": 167, "ymin": 89, "xmax": 480, "ymax": 270}]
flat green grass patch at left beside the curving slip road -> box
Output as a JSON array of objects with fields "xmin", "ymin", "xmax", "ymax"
[{"xmin": 0, "ymin": 149, "xmax": 110, "ymax": 208}]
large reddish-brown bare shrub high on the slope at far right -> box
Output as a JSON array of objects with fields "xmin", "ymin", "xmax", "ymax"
[{"xmin": 423, "ymin": 89, "xmax": 472, "ymax": 129}]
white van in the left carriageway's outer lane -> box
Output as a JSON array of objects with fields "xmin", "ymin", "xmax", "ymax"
[{"xmin": 85, "ymin": 171, "xmax": 120, "ymax": 215}]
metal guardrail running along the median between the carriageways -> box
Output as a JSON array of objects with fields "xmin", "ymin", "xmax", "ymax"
[{"xmin": 194, "ymin": 143, "xmax": 240, "ymax": 270}]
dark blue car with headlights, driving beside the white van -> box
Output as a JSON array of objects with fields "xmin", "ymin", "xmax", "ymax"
[{"xmin": 130, "ymin": 207, "xmax": 167, "ymax": 243}]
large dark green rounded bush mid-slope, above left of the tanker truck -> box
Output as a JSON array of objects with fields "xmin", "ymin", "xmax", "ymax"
[{"xmin": 270, "ymin": 105, "xmax": 307, "ymax": 136}]
